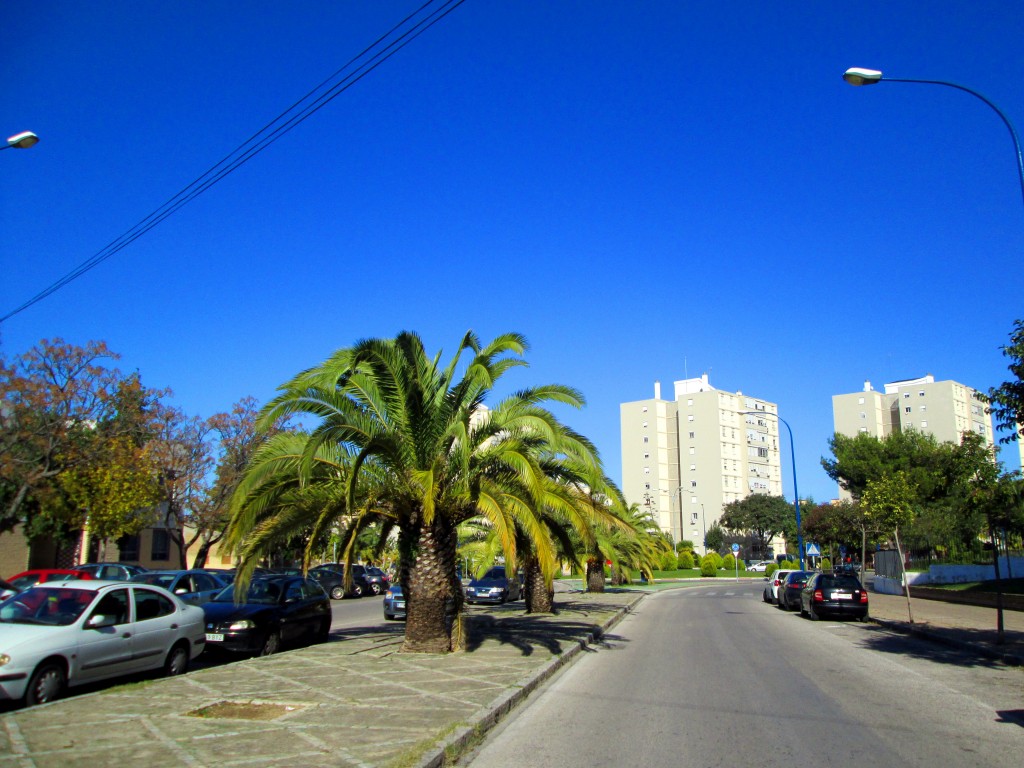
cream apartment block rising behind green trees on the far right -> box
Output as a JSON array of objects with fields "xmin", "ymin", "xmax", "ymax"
[{"xmin": 833, "ymin": 374, "xmax": 994, "ymax": 499}]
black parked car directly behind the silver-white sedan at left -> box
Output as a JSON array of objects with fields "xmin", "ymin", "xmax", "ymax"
[{"xmin": 202, "ymin": 575, "xmax": 331, "ymax": 656}]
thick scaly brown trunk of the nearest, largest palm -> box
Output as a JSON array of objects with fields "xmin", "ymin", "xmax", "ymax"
[{"xmin": 401, "ymin": 514, "xmax": 463, "ymax": 653}]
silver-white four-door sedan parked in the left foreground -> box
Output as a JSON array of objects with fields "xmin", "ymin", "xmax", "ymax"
[{"xmin": 0, "ymin": 581, "xmax": 206, "ymax": 706}]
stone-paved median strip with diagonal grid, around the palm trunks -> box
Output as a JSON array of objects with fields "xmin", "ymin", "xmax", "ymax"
[{"xmin": 0, "ymin": 591, "xmax": 643, "ymax": 768}]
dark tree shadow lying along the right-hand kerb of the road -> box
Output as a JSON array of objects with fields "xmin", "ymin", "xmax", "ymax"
[{"xmin": 864, "ymin": 624, "xmax": 1024, "ymax": 669}]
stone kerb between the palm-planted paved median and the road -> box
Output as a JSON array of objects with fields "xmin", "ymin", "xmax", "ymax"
[{"xmin": 413, "ymin": 593, "xmax": 653, "ymax": 768}]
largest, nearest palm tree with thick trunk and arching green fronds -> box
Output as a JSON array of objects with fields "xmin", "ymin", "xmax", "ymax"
[{"xmin": 224, "ymin": 332, "xmax": 591, "ymax": 652}]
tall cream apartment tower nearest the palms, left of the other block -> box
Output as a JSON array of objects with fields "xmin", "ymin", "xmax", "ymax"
[{"xmin": 618, "ymin": 374, "xmax": 782, "ymax": 553}]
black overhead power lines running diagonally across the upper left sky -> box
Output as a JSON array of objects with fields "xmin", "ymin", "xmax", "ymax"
[{"xmin": 0, "ymin": 0, "xmax": 465, "ymax": 324}]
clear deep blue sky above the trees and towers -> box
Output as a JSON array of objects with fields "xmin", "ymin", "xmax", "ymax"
[{"xmin": 0, "ymin": 0, "xmax": 1024, "ymax": 501}]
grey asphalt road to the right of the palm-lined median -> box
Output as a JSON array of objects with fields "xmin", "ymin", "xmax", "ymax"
[{"xmin": 462, "ymin": 583, "xmax": 1024, "ymax": 768}]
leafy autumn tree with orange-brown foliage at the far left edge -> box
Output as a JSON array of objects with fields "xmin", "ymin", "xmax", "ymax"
[{"xmin": 0, "ymin": 339, "xmax": 163, "ymax": 554}]
